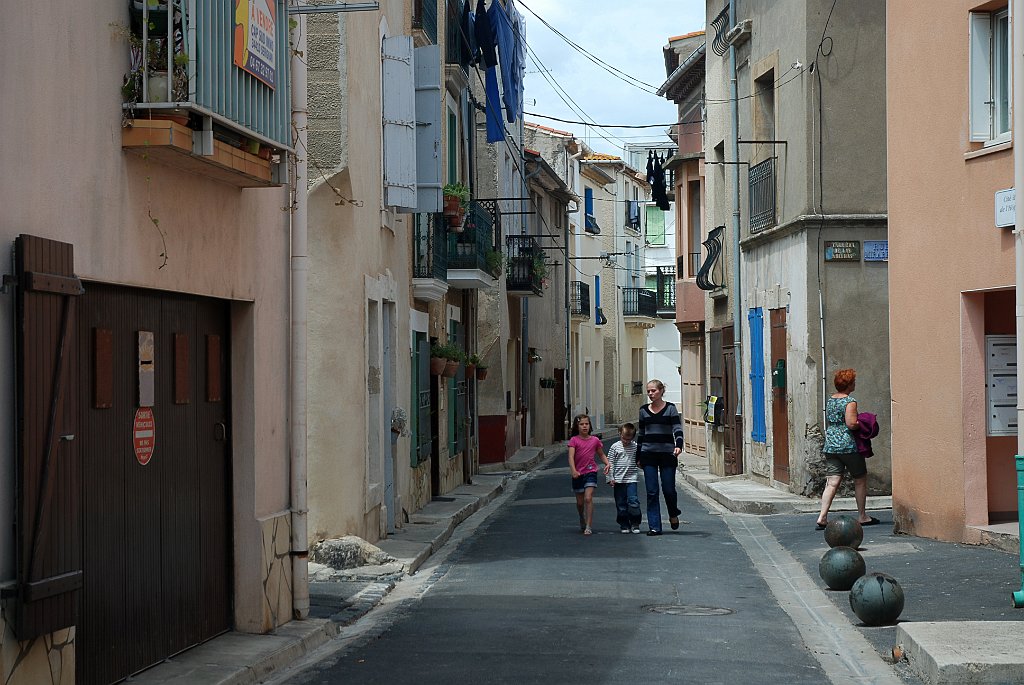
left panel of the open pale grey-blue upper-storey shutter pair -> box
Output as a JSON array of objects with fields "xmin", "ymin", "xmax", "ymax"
[{"xmin": 381, "ymin": 36, "xmax": 416, "ymax": 209}]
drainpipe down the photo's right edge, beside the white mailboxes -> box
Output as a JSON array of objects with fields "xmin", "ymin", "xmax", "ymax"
[{"xmin": 1011, "ymin": 0, "xmax": 1024, "ymax": 609}]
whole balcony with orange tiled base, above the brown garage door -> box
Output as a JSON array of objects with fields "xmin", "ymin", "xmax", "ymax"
[{"xmin": 115, "ymin": 0, "xmax": 292, "ymax": 187}]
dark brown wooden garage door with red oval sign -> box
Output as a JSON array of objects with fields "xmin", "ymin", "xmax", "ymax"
[{"xmin": 76, "ymin": 284, "xmax": 231, "ymax": 685}]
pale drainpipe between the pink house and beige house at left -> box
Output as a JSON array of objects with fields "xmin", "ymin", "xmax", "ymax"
[{"xmin": 289, "ymin": 0, "xmax": 309, "ymax": 618}]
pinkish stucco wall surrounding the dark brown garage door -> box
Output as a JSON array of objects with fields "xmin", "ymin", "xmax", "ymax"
[{"xmin": 0, "ymin": 0, "xmax": 291, "ymax": 684}]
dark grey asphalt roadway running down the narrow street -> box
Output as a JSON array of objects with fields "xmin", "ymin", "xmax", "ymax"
[{"xmin": 280, "ymin": 450, "xmax": 830, "ymax": 685}]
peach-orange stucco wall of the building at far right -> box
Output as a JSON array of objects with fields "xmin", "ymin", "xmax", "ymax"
[{"xmin": 886, "ymin": 1, "xmax": 1014, "ymax": 542}]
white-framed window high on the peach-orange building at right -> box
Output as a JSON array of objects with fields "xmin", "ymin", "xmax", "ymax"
[{"xmin": 971, "ymin": 8, "xmax": 1011, "ymax": 143}]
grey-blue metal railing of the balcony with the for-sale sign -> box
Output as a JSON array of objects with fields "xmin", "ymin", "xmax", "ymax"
[{"xmin": 122, "ymin": 0, "xmax": 292, "ymax": 148}]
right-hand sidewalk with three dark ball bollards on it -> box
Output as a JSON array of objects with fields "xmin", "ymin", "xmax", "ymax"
[{"xmin": 678, "ymin": 455, "xmax": 1024, "ymax": 685}]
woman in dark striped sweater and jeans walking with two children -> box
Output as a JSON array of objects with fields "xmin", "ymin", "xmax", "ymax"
[{"xmin": 637, "ymin": 379, "xmax": 683, "ymax": 536}]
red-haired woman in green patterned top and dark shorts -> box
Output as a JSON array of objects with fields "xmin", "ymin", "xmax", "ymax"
[{"xmin": 817, "ymin": 369, "xmax": 879, "ymax": 530}]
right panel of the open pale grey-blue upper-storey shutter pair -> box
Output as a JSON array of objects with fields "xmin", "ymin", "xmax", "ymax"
[{"xmin": 416, "ymin": 45, "xmax": 443, "ymax": 213}]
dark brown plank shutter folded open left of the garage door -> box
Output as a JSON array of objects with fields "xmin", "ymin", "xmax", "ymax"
[{"xmin": 13, "ymin": 236, "xmax": 84, "ymax": 640}]
